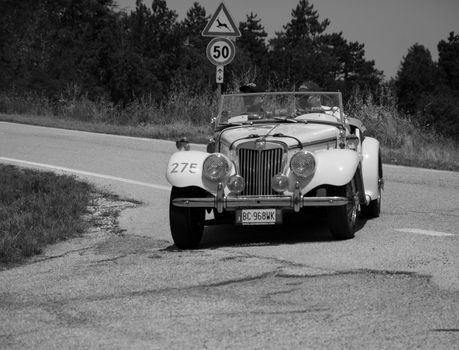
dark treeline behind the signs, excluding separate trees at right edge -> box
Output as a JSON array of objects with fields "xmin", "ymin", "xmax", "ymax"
[{"xmin": 0, "ymin": 0, "xmax": 380, "ymax": 106}]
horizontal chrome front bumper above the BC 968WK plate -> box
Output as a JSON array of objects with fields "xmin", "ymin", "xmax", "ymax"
[{"xmin": 172, "ymin": 185, "xmax": 349, "ymax": 213}]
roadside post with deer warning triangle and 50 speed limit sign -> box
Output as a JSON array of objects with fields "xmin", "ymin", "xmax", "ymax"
[{"xmin": 201, "ymin": 2, "xmax": 241, "ymax": 98}]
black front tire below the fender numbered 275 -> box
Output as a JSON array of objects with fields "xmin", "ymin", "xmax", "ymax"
[{"xmin": 169, "ymin": 187, "xmax": 205, "ymax": 249}]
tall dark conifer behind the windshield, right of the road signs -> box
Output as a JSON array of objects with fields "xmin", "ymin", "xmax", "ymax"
[{"xmin": 269, "ymin": 0, "xmax": 382, "ymax": 98}]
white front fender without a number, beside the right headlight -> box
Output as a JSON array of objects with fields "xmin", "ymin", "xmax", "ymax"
[{"xmin": 302, "ymin": 149, "xmax": 360, "ymax": 194}]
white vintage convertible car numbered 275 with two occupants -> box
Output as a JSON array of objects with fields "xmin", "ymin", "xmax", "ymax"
[{"xmin": 166, "ymin": 92, "xmax": 384, "ymax": 249}]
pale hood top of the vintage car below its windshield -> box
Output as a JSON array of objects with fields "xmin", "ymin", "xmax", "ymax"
[{"xmin": 220, "ymin": 123, "xmax": 338, "ymax": 148}]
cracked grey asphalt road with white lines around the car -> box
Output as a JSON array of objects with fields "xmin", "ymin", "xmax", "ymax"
[{"xmin": 0, "ymin": 122, "xmax": 459, "ymax": 349}]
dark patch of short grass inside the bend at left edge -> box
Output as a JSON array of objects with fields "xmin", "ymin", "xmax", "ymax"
[{"xmin": 0, "ymin": 164, "xmax": 95, "ymax": 263}]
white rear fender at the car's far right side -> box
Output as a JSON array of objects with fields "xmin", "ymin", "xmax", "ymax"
[{"xmin": 362, "ymin": 137, "xmax": 382, "ymax": 200}]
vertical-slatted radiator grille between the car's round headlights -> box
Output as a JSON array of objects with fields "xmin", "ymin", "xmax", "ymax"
[{"xmin": 238, "ymin": 147, "xmax": 284, "ymax": 195}]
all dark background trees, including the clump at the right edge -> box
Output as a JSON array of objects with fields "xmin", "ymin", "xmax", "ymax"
[{"xmin": 0, "ymin": 0, "xmax": 459, "ymax": 138}]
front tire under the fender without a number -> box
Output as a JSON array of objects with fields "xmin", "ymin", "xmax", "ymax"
[{"xmin": 327, "ymin": 180, "xmax": 359, "ymax": 240}]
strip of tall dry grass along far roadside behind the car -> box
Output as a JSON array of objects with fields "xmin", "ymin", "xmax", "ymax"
[{"xmin": 0, "ymin": 87, "xmax": 459, "ymax": 171}]
